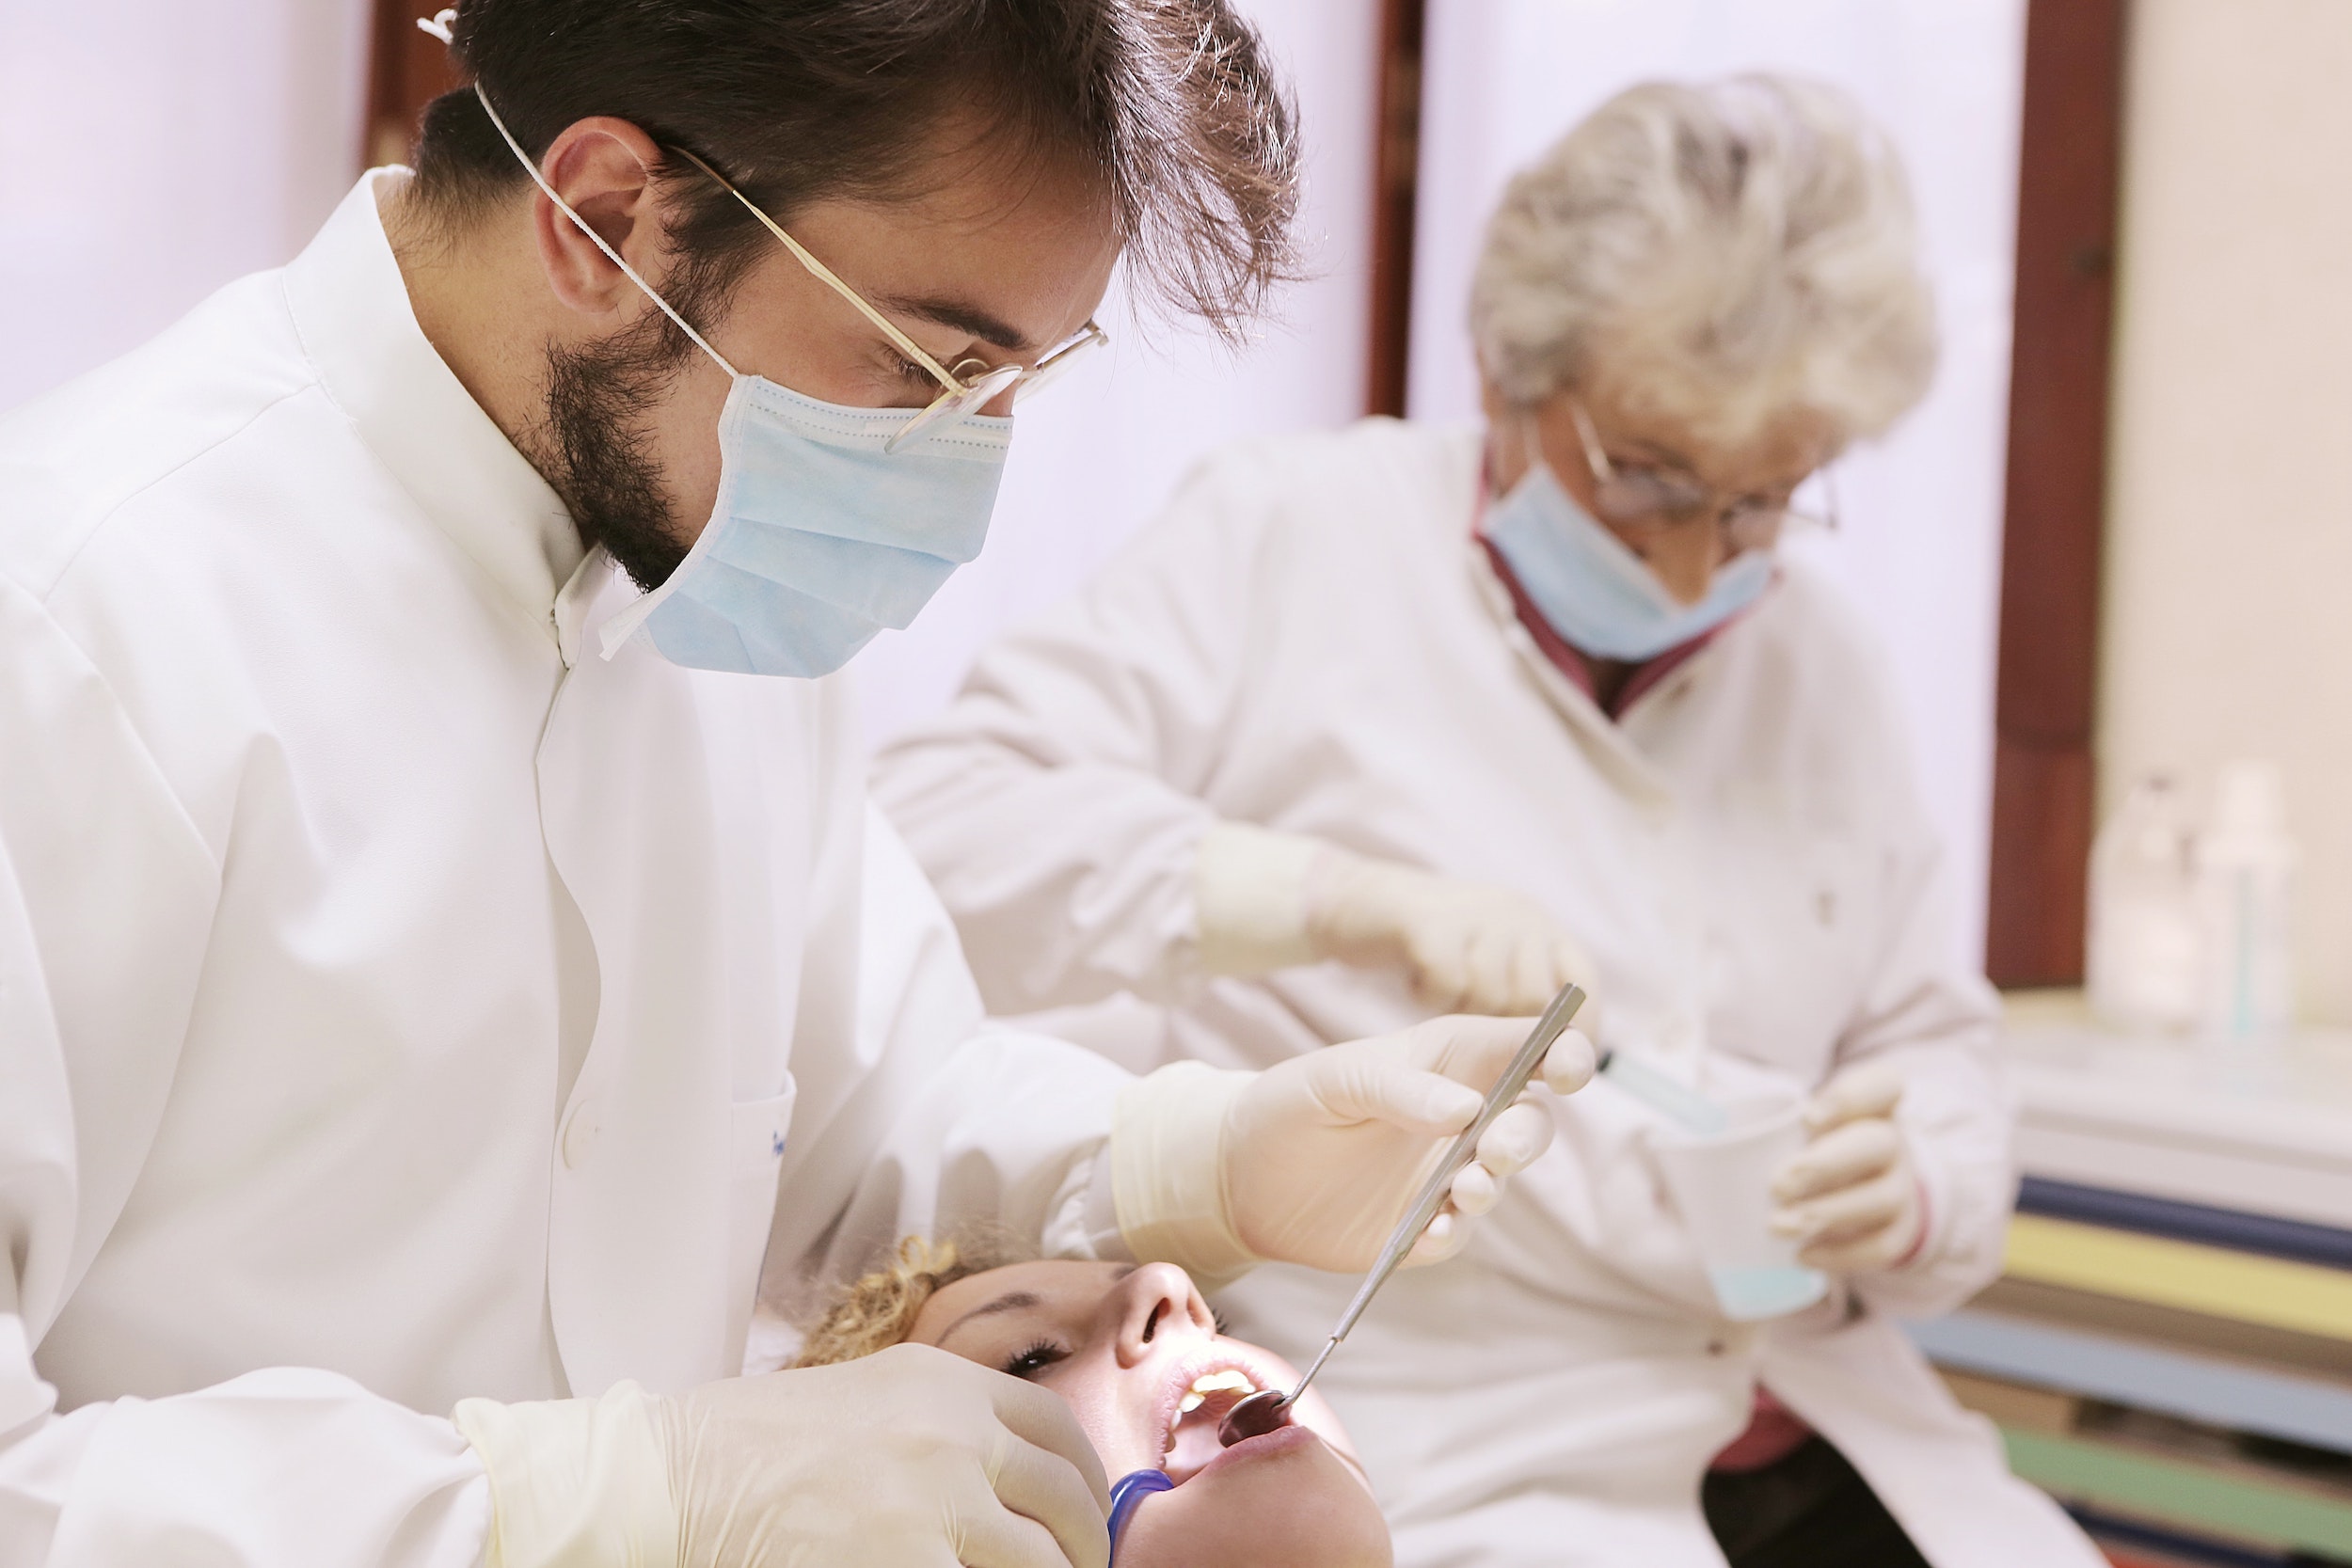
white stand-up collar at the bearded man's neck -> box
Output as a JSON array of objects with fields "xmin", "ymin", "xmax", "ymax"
[{"xmin": 285, "ymin": 166, "xmax": 593, "ymax": 641}]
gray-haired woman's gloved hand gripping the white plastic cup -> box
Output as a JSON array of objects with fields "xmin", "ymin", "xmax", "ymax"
[{"xmin": 1772, "ymin": 1063, "xmax": 1927, "ymax": 1275}]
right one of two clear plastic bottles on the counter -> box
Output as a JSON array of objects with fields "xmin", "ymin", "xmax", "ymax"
[{"xmin": 2197, "ymin": 762, "xmax": 2300, "ymax": 1041}]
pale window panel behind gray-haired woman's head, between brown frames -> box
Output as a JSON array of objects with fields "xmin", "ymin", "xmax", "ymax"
[{"xmin": 1409, "ymin": 0, "xmax": 2023, "ymax": 963}]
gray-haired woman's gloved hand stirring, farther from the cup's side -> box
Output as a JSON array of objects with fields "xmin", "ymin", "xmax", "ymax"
[{"xmin": 1306, "ymin": 844, "xmax": 1593, "ymax": 1016}]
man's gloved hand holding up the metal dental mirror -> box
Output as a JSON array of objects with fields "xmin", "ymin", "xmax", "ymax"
[{"xmin": 1110, "ymin": 1018, "xmax": 1593, "ymax": 1281}]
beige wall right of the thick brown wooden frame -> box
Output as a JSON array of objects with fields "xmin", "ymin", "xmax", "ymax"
[{"xmin": 2098, "ymin": 0, "xmax": 2352, "ymax": 1022}]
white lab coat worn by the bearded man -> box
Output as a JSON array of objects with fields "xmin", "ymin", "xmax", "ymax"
[{"xmin": 0, "ymin": 174, "xmax": 1124, "ymax": 1568}]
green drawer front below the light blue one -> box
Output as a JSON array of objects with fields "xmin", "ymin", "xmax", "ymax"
[{"xmin": 2002, "ymin": 1427, "xmax": 2352, "ymax": 1554}]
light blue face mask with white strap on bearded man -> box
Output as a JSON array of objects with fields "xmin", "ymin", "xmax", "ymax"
[{"xmin": 475, "ymin": 87, "xmax": 1014, "ymax": 677}]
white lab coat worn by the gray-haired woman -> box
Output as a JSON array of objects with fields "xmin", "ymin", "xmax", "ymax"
[{"xmin": 878, "ymin": 420, "xmax": 2101, "ymax": 1568}]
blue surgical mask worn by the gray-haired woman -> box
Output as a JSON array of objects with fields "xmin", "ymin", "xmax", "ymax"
[{"xmin": 1486, "ymin": 451, "xmax": 1773, "ymax": 663}]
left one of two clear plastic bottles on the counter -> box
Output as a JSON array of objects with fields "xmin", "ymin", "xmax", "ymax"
[{"xmin": 2087, "ymin": 773, "xmax": 2204, "ymax": 1035}]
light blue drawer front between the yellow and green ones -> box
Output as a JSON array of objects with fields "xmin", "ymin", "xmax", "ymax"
[{"xmin": 1905, "ymin": 1312, "xmax": 2352, "ymax": 1453}]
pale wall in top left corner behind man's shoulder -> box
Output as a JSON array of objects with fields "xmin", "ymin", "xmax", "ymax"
[{"xmin": 0, "ymin": 0, "xmax": 367, "ymax": 409}]
